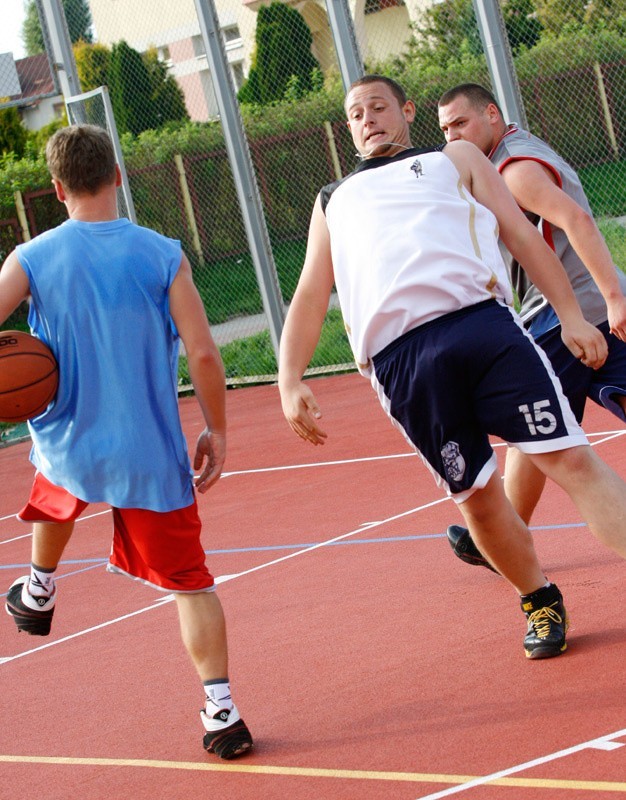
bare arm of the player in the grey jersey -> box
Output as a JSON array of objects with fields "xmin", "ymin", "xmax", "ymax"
[{"xmin": 502, "ymin": 159, "xmax": 626, "ymax": 341}]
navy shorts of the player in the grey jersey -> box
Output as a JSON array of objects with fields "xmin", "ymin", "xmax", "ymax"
[{"xmin": 536, "ymin": 322, "xmax": 626, "ymax": 422}]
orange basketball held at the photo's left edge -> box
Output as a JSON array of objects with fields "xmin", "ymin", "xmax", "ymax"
[{"xmin": 0, "ymin": 331, "xmax": 59, "ymax": 422}]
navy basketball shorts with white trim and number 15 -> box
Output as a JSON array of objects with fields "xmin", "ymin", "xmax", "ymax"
[{"xmin": 372, "ymin": 300, "xmax": 588, "ymax": 503}]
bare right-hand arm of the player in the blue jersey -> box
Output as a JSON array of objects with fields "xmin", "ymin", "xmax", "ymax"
[{"xmin": 170, "ymin": 255, "xmax": 226, "ymax": 492}]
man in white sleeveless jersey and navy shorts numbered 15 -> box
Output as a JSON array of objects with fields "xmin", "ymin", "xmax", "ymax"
[{"xmin": 279, "ymin": 75, "xmax": 626, "ymax": 659}]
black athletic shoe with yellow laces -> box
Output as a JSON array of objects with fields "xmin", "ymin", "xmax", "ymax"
[{"xmin": 521, "ymin": 583, "xmax": 569, "ymax": 658}]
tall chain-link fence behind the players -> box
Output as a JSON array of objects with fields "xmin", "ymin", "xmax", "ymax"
[{"xmin": 0, "ymin": 0, "xmax": 626, "ymax": 383}]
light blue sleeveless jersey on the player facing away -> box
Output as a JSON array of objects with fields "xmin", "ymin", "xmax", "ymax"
[{"xmin": 17, "ymin": 219, "xmax": 193, "ymax": 511}]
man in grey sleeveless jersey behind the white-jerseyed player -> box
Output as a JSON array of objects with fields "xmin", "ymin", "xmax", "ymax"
[{"xmin": 439, "ymin": 83, "xmax": 626, "ymax": 567}]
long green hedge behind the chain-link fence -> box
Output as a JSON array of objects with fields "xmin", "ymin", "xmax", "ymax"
[{"xmin": 0, "ymin": 31, "xmax": 626, "ymax": 256}]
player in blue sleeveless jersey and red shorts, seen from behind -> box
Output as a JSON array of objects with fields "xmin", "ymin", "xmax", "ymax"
[{"xmin": 0, "ymin": 125, "xmax": 252, "ymax": 758}]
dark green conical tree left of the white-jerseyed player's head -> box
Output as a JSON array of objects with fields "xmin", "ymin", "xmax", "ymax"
[{"xmin": 239, "ymin": 2, "xmax": 321, "ymax": 105}]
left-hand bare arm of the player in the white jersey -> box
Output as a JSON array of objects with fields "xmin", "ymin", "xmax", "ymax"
[{"xmin": 278, "ymin": 197, "xmax": 334, "ymax": 445}]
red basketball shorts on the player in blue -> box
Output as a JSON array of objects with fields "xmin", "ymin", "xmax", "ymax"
[{"xmin": 17, "ymin": 472, "xmax": 214, "ymax": 592}]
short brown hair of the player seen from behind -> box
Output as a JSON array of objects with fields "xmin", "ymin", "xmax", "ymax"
[{"xmin": 46, "ymin": 125, "xmax": 115, "ymax": 194}]
